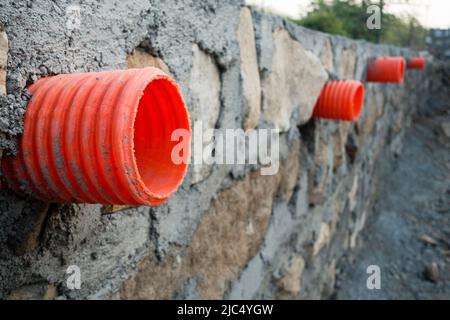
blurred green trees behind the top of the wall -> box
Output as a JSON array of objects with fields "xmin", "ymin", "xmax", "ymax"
[{"xmin": 294, "ymin": 0, "xmax": 428, "ymax": 49}]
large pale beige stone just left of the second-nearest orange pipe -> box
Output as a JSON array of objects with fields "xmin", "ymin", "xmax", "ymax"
[{"xmin": 262, "ymin": 28, "xmax": 328, "ymax": 131}]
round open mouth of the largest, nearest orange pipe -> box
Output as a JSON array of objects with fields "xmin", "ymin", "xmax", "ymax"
[{"xmin": 133, "ymin": 78, "xmax": 190, "ymax": 198}]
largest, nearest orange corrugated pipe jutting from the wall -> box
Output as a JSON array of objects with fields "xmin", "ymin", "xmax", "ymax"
[{"xmin": 2, "ymin": 68, "xmax": 191, "ymax": 205}]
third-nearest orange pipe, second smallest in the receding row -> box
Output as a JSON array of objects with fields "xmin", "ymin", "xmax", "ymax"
[{"xmin": 367, "ymin": 57, "xmax": 406, "ymax": 83}]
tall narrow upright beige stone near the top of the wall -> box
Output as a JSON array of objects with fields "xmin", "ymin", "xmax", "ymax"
[{"xmin": 238, "ymin": 7, "xmax": 261, "ymax": 130}]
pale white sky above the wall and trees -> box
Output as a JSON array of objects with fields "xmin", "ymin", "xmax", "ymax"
[{"xmin": 246, "ymin": 0, "xmax": 450, "ymax": 29}]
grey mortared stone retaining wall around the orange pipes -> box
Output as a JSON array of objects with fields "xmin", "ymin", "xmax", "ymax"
[{"xmin": 0, "ymin": 0, "xmax": 428, "ymax": 299}]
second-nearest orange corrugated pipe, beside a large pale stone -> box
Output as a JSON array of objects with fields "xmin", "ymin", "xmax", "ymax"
[{"xmin": 313, "ymin": 80, "xmax": 364, "ymax": 121}]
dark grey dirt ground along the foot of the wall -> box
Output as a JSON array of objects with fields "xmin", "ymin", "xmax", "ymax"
[{"xmin": 333, "ymin": 103, "xmax": 450, "ymax": 299}]
